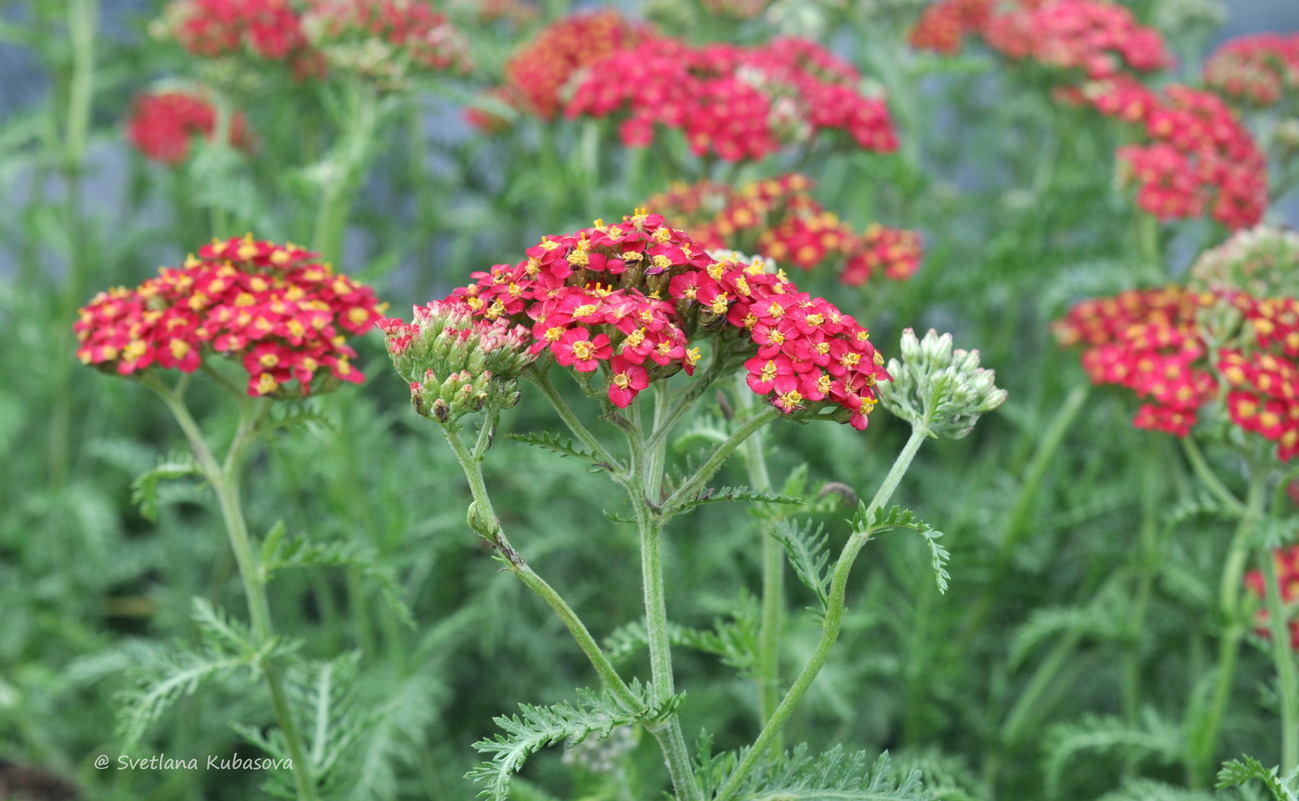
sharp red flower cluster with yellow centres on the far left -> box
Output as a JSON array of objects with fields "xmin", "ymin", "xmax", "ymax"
[{"xmin": 73, "ymin": 236, "xmax": 381, "ymax": 396}]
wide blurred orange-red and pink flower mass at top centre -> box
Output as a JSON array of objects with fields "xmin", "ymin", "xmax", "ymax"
[{"xmin": 475, "ymin": 10, "xmax": 898, "ymax": 161}]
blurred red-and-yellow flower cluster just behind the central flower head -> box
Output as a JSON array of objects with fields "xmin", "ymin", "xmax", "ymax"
[{"xmin": 647, "ymin": 173, "xmax": 921, "ymax": 286}]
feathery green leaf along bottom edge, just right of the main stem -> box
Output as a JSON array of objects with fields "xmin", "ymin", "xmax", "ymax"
[{"xmin": 698, "ymin": 739, "xmax": 937, "ymax": 801}]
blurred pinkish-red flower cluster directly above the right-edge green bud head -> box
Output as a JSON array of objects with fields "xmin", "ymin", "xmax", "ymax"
[{"xmin": 1078, "ymin": 79, "xmax": 1268, "ymax": 230}]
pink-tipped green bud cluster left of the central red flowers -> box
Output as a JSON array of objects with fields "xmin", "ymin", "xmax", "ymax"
[{"xmin": 379, "ymin": 300, "xmax": 535, "ymax": 423}]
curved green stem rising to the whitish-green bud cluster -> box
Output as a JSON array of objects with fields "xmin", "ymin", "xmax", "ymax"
[{"xmin": 716, "ymin": 426, "xmax": 929, "ymax": 801}]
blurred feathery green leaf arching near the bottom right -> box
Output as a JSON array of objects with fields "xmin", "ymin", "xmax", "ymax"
[{"xmin": 1043, "ymin": 709, "xmax": 1186, "ymax": 797}]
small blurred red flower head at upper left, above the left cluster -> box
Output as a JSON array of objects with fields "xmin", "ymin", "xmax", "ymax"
[{"xmin": 126, "ymin": 91, "xmax": 252, "ymax": 165}]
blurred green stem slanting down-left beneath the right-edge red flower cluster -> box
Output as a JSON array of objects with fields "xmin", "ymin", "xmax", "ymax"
[{"xmin": 1186, "ymin": 471, "xmax": 1265, "ymax": 789}]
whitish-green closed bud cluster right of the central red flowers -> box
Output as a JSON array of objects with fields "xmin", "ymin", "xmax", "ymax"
[{"xmin": 879, "ymin": 328, "xmax": 1007, "ymax": 439}]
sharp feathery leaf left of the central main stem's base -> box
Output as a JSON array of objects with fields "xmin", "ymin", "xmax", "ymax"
[{"xmin": 465, "ymin": 683, "xmax": 681, "ymax": 801}]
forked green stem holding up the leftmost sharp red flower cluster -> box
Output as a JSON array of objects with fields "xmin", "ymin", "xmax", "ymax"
[{"xmin": 145, "ymin": 376, "xmax": 318, "ymax": 801}]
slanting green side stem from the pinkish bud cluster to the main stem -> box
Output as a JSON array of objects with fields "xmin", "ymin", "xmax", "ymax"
[{"xmin": 442, "ymin": 415, "xmax": 642, "ymax": 709}]
